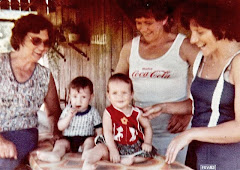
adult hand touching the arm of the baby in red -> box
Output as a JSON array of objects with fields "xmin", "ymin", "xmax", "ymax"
[{"xmin": 142, "ymin": 103, "xmax": 166, "ymax": 119}]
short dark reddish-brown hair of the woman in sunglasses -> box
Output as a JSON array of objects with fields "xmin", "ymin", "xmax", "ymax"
[{"xmin": 10, "ymin": 14, "xmax": 55, "ymax": 50}]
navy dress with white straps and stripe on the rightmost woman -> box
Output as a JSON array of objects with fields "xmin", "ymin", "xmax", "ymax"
[{"xmin": 186, "ymin": 51, "xmax": 240, "ymax": 170}]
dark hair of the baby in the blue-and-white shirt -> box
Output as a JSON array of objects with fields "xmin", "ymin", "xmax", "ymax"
[{"xmin": 68, "ymin": 76, "xmax": 93, "ymax": 94}]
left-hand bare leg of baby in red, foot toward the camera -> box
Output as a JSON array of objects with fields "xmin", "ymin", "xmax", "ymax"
[{"xmin": 82, "ymin": 143, "xmax": 109, "ymax": 170}]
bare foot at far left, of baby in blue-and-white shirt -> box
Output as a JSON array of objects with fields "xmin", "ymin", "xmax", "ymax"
[{"xmin": 37, "ymin": 151, "xmax": 61, "ymax": 162}]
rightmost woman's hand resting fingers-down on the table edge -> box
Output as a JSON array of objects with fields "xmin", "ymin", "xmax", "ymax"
[{"xmin": 165, "ymin": 130, "xmax": 192, "ymax": 164}]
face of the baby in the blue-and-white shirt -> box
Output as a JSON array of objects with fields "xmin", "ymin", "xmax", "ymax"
[{"xmin": 70, "ymin": 87, "xmax": 92, "ymax": 112}]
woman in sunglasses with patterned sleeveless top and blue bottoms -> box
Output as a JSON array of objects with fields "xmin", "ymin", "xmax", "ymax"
[{"xmin": 0, "ymin": 14, "xmax": 61, "ymax": 170}]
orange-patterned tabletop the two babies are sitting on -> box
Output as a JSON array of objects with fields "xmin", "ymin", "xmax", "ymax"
[{"xmin": 29, "ymin": 135, "xmax": 190, "ymax": 170}]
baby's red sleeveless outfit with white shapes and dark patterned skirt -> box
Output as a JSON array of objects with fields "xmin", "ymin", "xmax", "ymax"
[{"xmin": 106, "ymin": 105, "xmax": 156, "ymax": 157}]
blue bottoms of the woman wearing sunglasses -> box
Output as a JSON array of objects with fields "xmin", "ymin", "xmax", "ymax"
[{"xmin": 0, "ymin": 128, "xmax": 38, "ymax": 170}]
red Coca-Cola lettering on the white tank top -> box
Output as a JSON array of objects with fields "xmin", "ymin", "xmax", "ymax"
[{"xmin": 132, "ymin": 70, "xmax": 171, "ymax": 79}]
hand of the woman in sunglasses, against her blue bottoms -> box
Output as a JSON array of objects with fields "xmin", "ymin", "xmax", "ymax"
[{"xmin": 0, "ymin": 136, "xmax": 17, "ymax": 159}]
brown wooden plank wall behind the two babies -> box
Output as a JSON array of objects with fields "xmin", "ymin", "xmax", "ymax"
[{"xmin": 43, "ymin": 0, "xmax": 135, "ymax": 114}]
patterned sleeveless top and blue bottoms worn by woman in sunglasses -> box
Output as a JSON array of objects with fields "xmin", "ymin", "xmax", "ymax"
[{"xmin": 0, "ymin": 53, "xmax": 50, "ymax": 170}]
